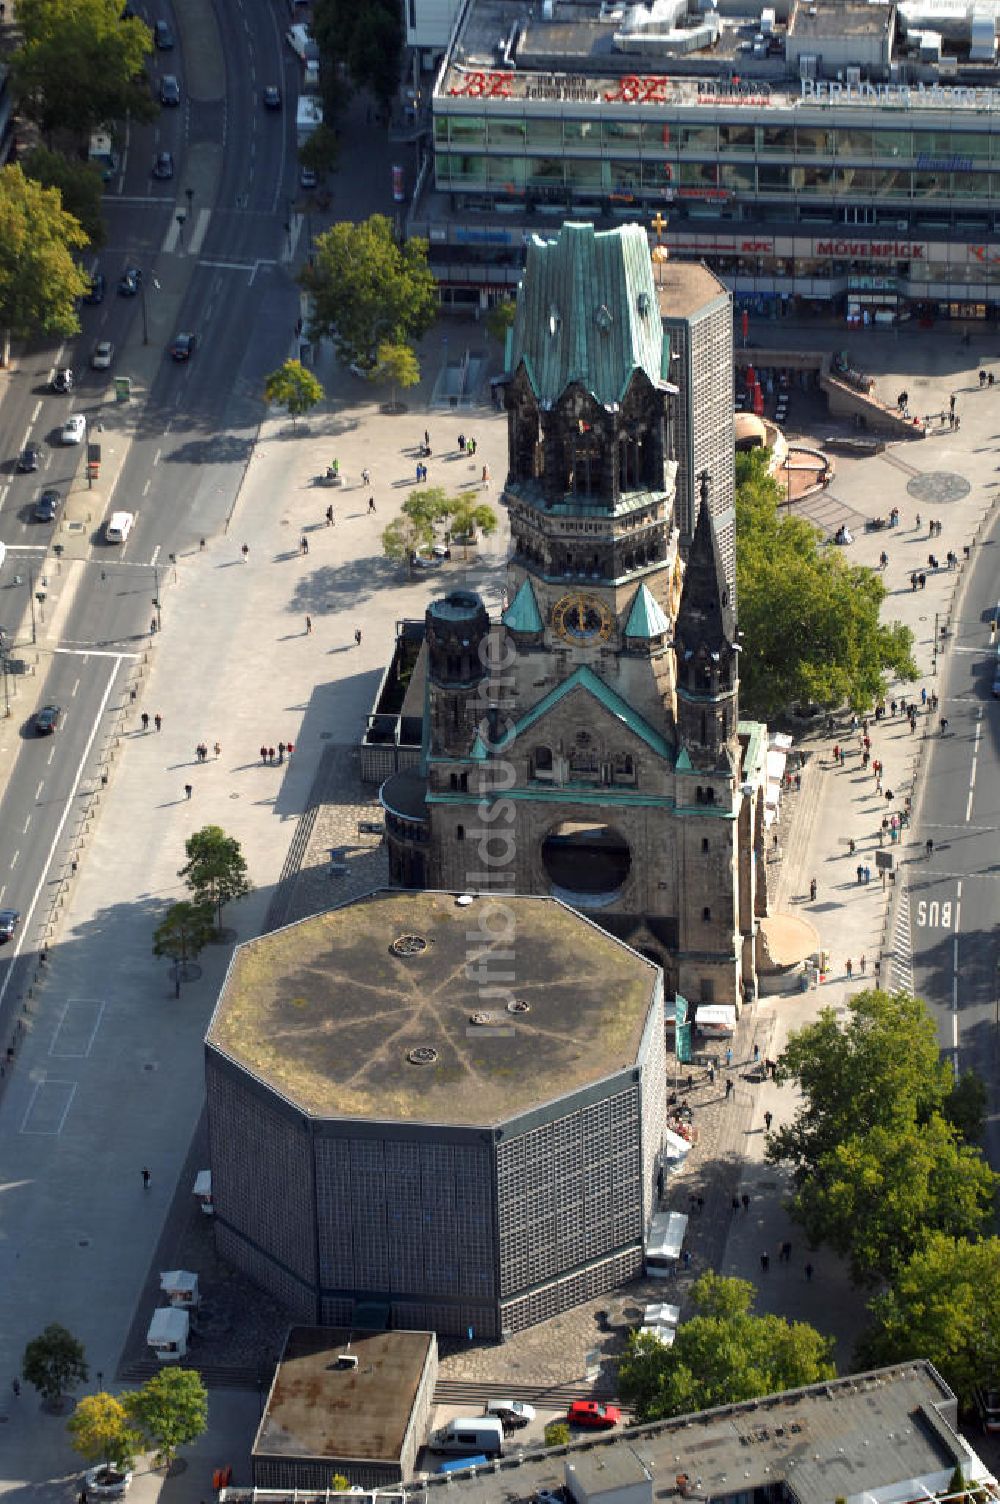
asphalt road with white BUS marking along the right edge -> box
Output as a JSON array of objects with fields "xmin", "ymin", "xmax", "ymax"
[{"xmin": 907, "ymin": 511, "xmax": 1000, "ymax": 1169}]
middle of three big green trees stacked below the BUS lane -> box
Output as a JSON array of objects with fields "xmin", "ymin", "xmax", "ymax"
[{"xmin": 792, "ymin": 1113, "xmax": 1000, "ymax": 1284}]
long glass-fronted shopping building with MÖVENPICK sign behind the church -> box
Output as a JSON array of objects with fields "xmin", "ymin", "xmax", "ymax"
[{"xmin": 409, "ymin": 0, "xmax": 1000, "ymax": 323}]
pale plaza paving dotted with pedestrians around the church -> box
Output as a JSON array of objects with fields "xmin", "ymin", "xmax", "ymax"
[{"xmin": 0, "ymin": 314, "xmax": 1000, "ymax": 1504}]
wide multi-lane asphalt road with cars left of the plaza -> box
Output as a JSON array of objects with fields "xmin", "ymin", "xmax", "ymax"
[{"xmin": 0, "ymin": 0, "xmax": 302, "ymax": 1033}]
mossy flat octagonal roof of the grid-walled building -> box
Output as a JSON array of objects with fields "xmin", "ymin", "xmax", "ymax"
[{"xmin": 206, "ymin": 890, "xmax": 659, "ymax": 1126}]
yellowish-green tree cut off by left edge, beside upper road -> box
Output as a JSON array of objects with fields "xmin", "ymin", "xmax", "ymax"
[{"xmin": 0, "ymin": 167, "xmax": 90, "ymax": 364}]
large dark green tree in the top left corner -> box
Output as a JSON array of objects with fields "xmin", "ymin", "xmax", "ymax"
[{"xmin": 12, "ymin": 0, "xmax": 156, "ymax": 141}]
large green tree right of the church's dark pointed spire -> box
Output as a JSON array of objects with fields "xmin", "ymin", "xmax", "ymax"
[{"xmin": 735, "ymin": 450, "xmax": 917, "ymax": 717}]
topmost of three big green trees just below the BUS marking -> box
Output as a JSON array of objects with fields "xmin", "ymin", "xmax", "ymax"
[{"xmin": 767, "ymin": 990, "xmax": 952, "ymax": 1182}]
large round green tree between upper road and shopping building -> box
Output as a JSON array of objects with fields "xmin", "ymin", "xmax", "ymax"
[{"xmin": 299, "ymin": 214, "xmax": 438, "ymax": 370}]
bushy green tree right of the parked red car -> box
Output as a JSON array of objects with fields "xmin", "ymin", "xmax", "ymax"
[{"xmin": 618, "ymin": 1272, "xmax": 836, "ymax": 1421}]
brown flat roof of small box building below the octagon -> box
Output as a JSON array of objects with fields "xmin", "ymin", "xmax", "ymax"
[{"xmin": 254, "ymin": 1327, "xmax": 435, "ymax": 1462}]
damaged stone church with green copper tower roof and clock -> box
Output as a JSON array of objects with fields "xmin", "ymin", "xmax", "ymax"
[{"xmin": 382, "ymin": 224, "xmax": 767, "ymax": 1008}]
